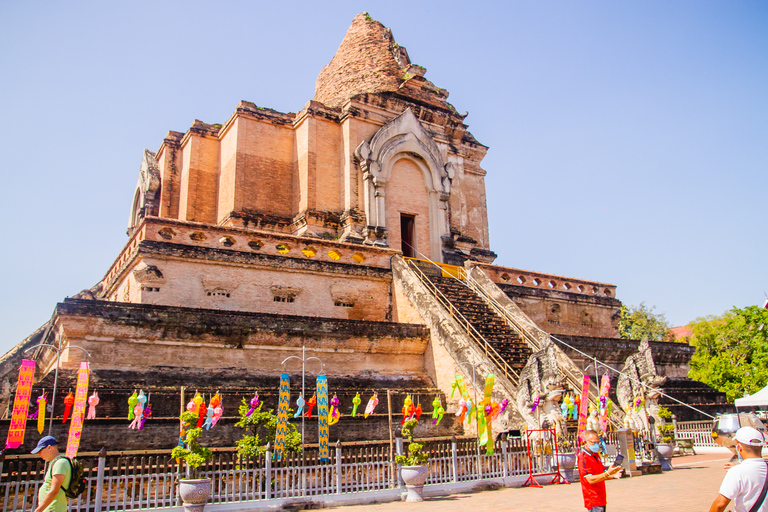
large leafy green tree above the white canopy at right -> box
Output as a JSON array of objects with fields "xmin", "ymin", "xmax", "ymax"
[{"xmin": 688, "ymin": 306, "xmax": 768, "ymax": 402}]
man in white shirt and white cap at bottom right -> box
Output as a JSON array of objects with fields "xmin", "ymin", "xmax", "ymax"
[{"xmin": 709, "ymin": 427, "xmax": 768, "ymax": 512}]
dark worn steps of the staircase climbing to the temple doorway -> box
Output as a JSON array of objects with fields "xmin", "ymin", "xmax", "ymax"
[{"xmin": 408, "ymin": 265, "xmax": 531, "ymax": 375}]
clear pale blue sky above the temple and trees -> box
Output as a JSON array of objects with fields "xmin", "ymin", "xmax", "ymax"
[{"xmin": 0, "ymin": 0, "xmax": 768, "ymax": 353}]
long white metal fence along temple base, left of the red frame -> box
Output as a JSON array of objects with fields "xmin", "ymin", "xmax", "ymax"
[{"xmin": 0, "ymin": 439, "xmax": 528, "ymax": 512}]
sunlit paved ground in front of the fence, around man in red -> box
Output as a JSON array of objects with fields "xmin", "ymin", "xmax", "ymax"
[{"xmin": 322, "ymin": 452, "xmax": 744, "ymax": 512}]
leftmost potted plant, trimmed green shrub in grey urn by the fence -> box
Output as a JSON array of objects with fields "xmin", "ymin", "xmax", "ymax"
[{"xmin": 171, "ymin": 411, "xmax": 213, "ymax": 512}]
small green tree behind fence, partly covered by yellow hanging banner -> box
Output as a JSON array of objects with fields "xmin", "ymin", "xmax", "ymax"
[{"xmin": 235, "ymin": 398, "xmax": 301, "ymax": 458}]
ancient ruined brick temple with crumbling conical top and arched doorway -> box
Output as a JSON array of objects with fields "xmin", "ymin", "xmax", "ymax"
[{"xmin": 0, "ymin": 13, "xmax": 724, "ymax": 449}]
